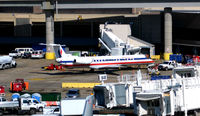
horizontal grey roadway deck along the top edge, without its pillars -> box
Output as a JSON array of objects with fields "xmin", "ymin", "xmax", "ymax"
[{"xmin": 0, "ymin": 0, "xmax": 200, "ymax": 9}]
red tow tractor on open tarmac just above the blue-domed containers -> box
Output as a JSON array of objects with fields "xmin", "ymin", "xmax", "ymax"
[{"xmin": 10, "ymin": 79, "xmax": 29, "ymax": 92}]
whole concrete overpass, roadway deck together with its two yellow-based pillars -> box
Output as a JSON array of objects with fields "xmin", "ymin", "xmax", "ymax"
[{"xmin": 0, "ymin": 0, "xmax": 200, "ymax": 60}]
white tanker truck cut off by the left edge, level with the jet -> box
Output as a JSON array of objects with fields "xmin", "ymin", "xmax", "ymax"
[{"xmin": 0, "ymin": 56, "xmax": 17, "ymax": 70}]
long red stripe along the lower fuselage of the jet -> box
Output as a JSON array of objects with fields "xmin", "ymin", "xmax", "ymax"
[{"xmin": 63, "ymin": 61, "xmax": 154, "ymax": 67}]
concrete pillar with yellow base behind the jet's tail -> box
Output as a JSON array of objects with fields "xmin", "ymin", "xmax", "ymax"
[{"xmin": 45, "ymin": 10, "xmax": 55, "ymax": 59}]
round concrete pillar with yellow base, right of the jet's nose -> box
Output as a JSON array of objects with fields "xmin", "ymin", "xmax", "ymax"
[{"xmin": 164, "ymin": 8, "xmax": 172, "ymax": 60}]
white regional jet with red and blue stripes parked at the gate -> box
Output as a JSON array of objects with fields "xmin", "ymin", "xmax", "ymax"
[{"xmin": 54, "ymin": 46, "xmax": 154, "ymax": 69}]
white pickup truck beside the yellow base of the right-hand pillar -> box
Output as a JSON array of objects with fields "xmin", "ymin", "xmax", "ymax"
[{"xmin": 158, "ymin": 61, "xmax": 176, "ymax": 71}]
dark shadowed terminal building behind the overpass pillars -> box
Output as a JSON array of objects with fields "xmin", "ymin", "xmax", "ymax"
[{"xmin": 0, "ymin": 7, "xmax": 200, "ymax": 58}]
